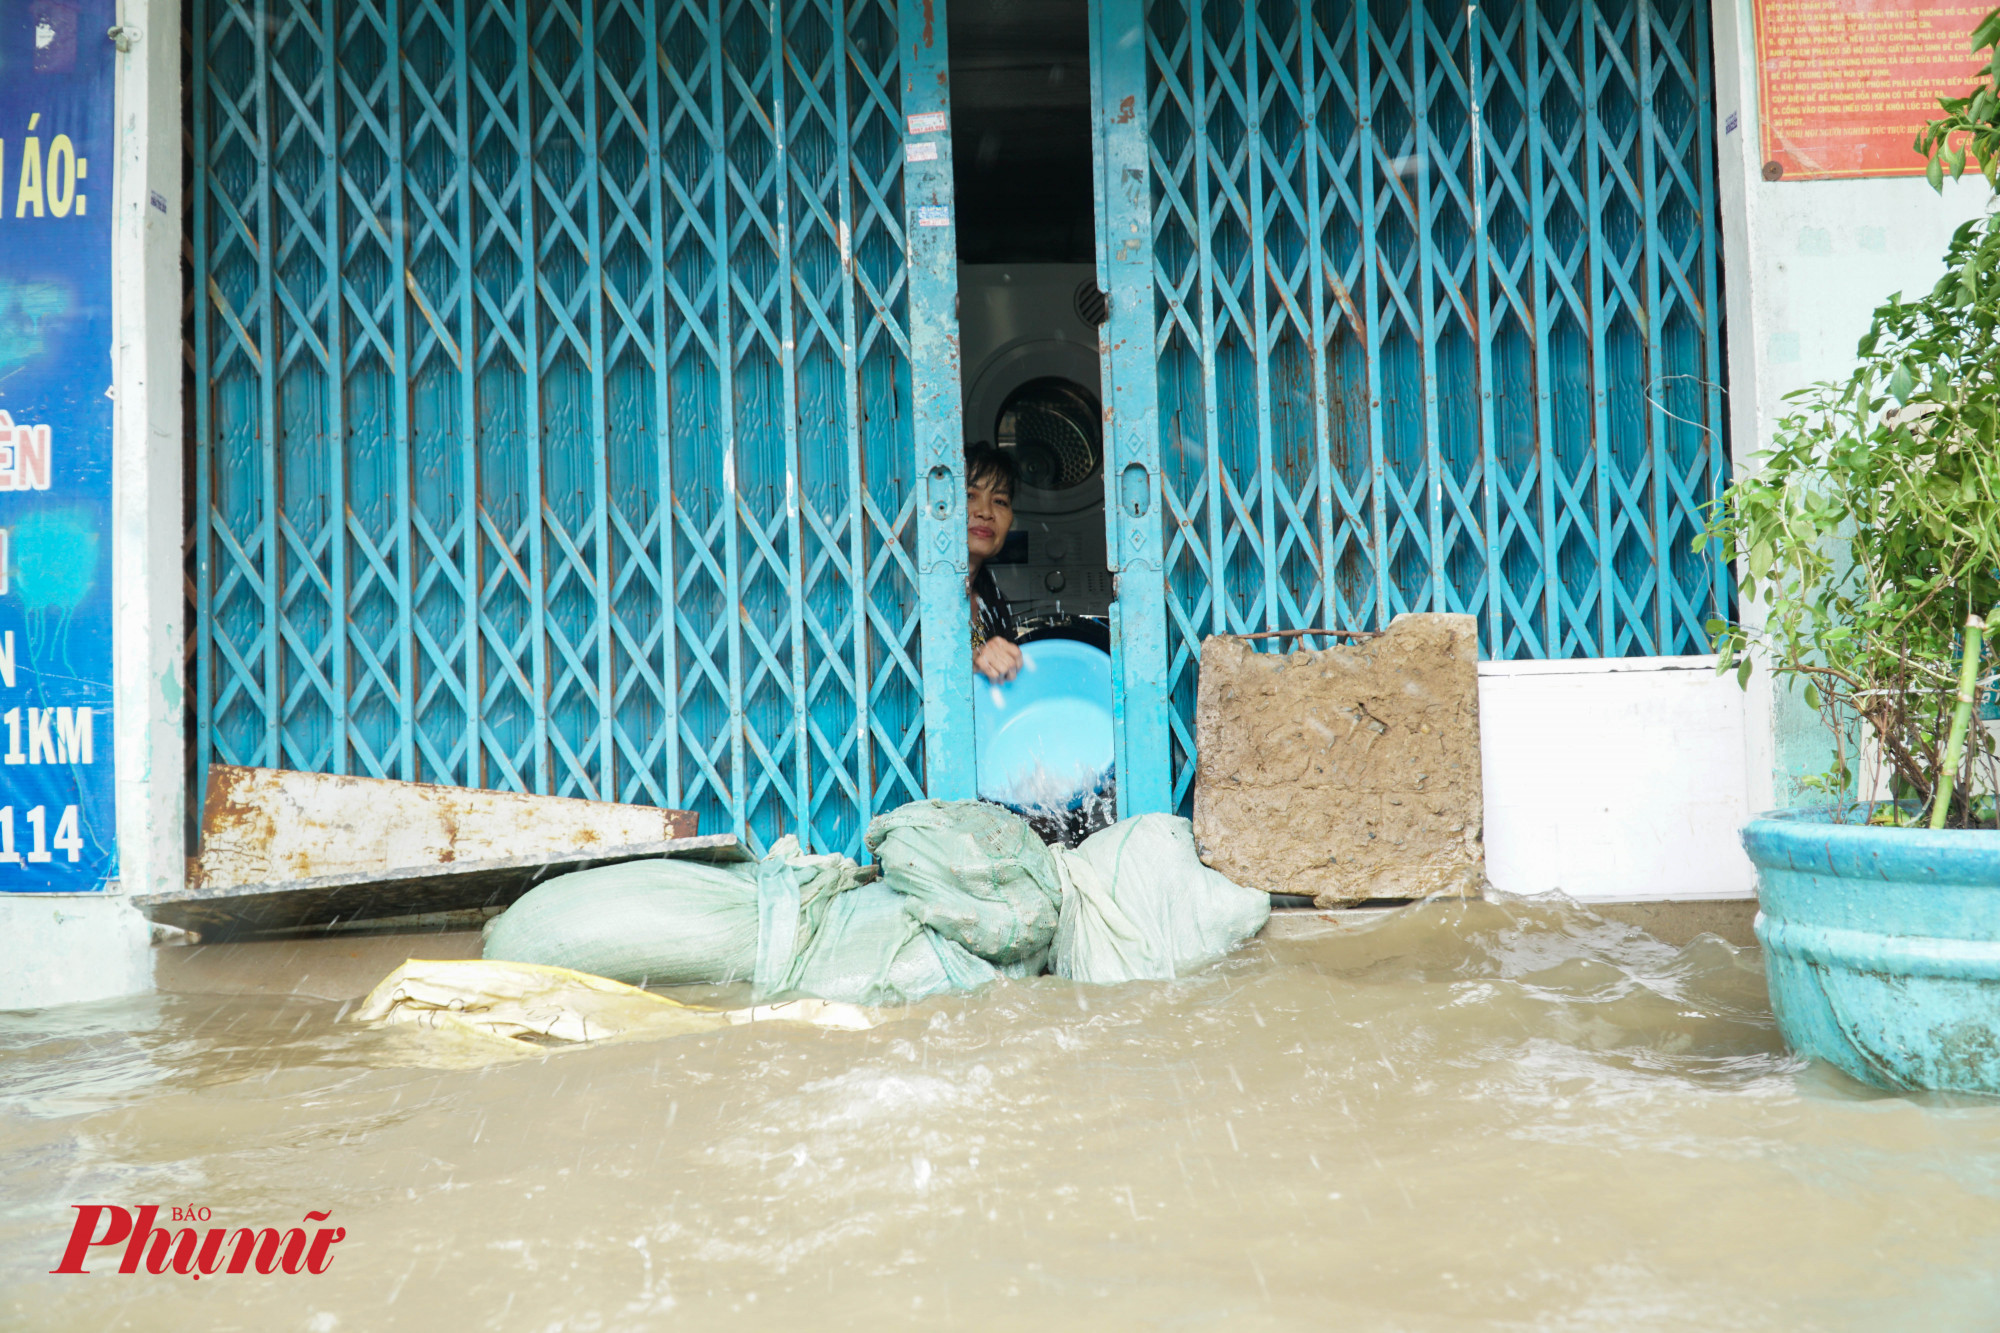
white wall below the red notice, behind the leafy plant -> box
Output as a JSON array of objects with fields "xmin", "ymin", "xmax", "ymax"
[{"xmin": 1714, "ymin": 0, "xmax": 1990, "ymax": 809}]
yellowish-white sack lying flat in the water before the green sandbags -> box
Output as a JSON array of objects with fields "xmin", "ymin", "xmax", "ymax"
[{"xmin": 352, "ymin": 959, "xmax": 874, "ymax": 1053}]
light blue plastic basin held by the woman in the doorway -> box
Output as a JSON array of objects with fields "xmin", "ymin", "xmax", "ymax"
[{"xmin": 972, "ymin": 638, "xmax": 1112, "ymax": 809}]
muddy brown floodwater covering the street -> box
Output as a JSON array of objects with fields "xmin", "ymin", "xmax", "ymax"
[{"xmin": 0, "ymin": 903, "xmax": 2000, "ymax": 1333}]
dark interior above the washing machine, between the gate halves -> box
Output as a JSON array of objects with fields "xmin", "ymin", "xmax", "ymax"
[{"xmin": 948, "ymin": 0, "xmax": 1096, "ymax": 264}]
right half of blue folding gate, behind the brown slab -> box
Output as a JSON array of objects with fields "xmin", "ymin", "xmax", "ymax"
[{"xmin": 1092, "ymin": 0, "xmax": 1728, "ymax": 811}]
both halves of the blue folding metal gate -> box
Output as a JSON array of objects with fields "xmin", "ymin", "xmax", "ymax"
[{"xmin": 188, "ymin": 0, "xmax": 1726, "ymax": 840}]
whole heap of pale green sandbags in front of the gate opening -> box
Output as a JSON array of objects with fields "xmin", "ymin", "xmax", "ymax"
[{"xmin": 484, "ymin": 801, "xmax": 1270, "ymax": 1005}]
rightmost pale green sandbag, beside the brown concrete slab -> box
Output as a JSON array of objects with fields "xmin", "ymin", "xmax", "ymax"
[{"xmin": 1050, "ymin": 815, "xmax": 1270, "ymax": 983}]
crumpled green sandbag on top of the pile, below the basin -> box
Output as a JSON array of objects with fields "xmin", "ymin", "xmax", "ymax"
[{"xmin": 866, "ymin": 801, "xmax": 1062, "ymax": 971}]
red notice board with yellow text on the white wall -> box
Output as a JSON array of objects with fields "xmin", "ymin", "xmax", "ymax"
[{"xmin": 1756, "ymin": 0, "xmax": 1994, "ymax": 180}]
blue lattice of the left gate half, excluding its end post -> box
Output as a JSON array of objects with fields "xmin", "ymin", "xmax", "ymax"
[{"xmin": 190, "ymin": 0, "xmax": 924, "ymax": 853}]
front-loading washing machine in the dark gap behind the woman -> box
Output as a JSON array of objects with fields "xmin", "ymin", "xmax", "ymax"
[{"xmin": 958, "ymin": 264, "xmax": 1112, "ymax": 624}]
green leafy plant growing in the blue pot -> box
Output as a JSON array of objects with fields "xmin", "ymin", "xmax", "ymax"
[{"xmin": 1696, "ymin": 10, "xmax": 2000, "ymax": 829}]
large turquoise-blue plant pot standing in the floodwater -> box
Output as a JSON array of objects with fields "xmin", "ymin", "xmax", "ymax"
[{"xmin": 1742, "ymin": 807, "xmax": 2000, "ymax": 1093}]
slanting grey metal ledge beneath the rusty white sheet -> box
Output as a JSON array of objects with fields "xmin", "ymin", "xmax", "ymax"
[{"xmin": 132, "ymin": 833, "xmax": 752, "ymax": 941}]
